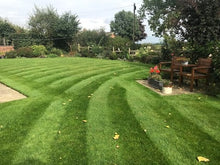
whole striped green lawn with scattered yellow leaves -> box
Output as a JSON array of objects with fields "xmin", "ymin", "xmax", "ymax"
[{"xmin": 0, "ymin": 58, "xmax": 220, "ymax": 165}]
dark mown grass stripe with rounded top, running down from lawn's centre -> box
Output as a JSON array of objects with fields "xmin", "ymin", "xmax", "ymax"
[{"xmin": 108, "ymin": 85, "xmax": 169, "ymax": 164}]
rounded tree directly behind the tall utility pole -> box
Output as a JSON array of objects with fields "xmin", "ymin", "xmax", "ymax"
[{"xmin": 110, "ymin": 10, "xmax": 147, "ymax": 41}]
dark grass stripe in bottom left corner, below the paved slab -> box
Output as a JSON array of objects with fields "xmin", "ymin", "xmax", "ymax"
[{"xmin": 0, "ymin": 98, "xmax": 50, "ymax": 164}]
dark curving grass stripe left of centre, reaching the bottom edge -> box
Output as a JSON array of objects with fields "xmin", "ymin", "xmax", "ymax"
[{"xmin": 48, "ymin": 71, "xmax": 117, "ymax": 164}]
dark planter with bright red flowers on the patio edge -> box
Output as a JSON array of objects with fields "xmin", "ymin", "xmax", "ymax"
[{"xmin": 148, "ymin": 66, "xmax": 163, "ymax": 90}]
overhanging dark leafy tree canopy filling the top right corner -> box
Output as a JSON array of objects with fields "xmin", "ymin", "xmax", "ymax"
[{"xmin": 140, "ymin": 0, "xmax": 220, "ymax": 44}]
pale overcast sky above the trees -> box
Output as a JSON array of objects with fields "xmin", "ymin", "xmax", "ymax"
[{"xmin": 0, "ymin": 0, "xmax": 160, "ymax": 43}]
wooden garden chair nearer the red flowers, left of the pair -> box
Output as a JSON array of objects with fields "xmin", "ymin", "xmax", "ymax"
[{"xmin": 159, "ymin": 56, "xmax": 187, "ymax": 82}]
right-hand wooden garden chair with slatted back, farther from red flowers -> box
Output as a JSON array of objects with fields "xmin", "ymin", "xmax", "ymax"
[{"xmin": 179, "ymin": 58, "xmax": 212, "ymax": 92}]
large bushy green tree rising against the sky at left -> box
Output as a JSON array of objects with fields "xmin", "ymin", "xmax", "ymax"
[{"xmin": 29, "ymin": 7, "xmax": 80, "ymax": 49}]
